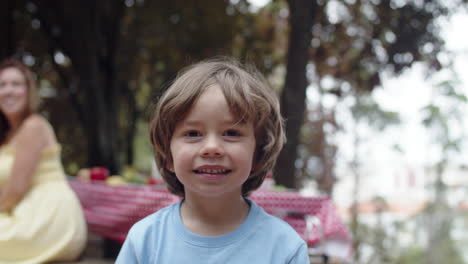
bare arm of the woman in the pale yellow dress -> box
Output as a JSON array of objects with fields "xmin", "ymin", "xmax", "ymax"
[{"xmin": 0, "ymin": 115, "xmax": 55, "ymax": 212}]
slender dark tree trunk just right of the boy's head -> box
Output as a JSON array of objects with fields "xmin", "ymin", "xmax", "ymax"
[{"xmin": 274, "ymin": 0, "xmax": 317, "ymax": 188}]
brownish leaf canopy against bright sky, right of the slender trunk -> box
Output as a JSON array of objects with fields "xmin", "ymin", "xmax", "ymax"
[{"xmin": 311, "ymin": 0, "xmax": 448, "ymax": 93}]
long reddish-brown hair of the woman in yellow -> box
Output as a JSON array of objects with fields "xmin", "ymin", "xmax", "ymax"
[{"xmin": 0, "ymin": 59, "xmax": 38, "ymax": 145}]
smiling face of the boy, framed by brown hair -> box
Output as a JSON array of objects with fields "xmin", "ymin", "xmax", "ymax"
[{"xmin": 167, "ymin": 85, "xmax": 255, "ymax": 197}]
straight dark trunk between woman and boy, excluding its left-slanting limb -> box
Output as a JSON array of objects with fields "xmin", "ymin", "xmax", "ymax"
[{"xmin": 75, "ymin": 1, "xmax": 124, "ymax": 174}]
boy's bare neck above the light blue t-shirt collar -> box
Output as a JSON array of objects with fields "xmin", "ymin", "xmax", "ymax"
[{"xmin": 180, "ymin": 195, "xmax": 249, "ymax": 236}]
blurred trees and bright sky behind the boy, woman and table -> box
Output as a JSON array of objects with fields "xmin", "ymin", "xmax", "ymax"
[{"xmin": 0, "ymin": 0, "xmax": 468, "ymax": 263}]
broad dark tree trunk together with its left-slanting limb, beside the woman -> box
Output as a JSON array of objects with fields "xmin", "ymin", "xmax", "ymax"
[{"xmin": 35, "ymin": 0, "xmax": 125, "ymax": 174}]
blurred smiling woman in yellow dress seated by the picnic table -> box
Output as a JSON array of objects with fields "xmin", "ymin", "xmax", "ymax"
[{"xmin": 0, "ymin": 59, "xmax": 87, "ymax": 263}]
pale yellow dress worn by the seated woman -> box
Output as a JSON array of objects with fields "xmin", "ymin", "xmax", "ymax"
[{"xmin": 0, "ymin": 144, "xmax": 87, "ymax": 264}]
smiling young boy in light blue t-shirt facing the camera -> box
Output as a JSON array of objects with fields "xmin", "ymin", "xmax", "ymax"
[{"xmin": 117, "ymin": 59, "xmax": 309, "ymax": 264}]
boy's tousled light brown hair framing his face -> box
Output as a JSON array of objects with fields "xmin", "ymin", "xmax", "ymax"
[{"xmin": 150, "ymin": 58, "xmax": 285, "ymax": 197}]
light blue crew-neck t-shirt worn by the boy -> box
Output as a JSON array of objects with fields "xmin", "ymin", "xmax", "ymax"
[{"xmin": 116, "ymin": 200, "xmax": 310, "ymax": 264}]
